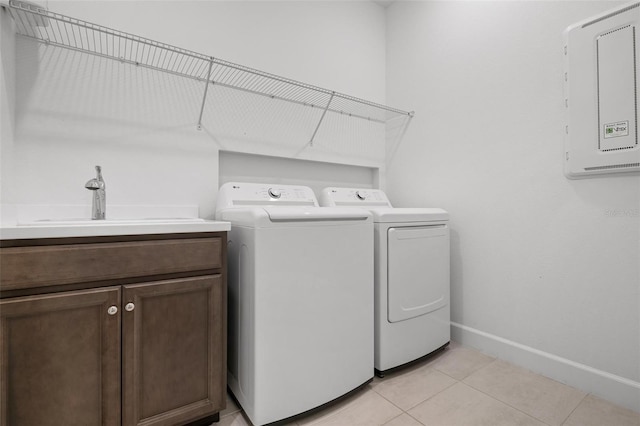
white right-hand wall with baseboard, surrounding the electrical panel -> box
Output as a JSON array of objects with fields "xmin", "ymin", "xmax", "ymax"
[{"xmin": 387, "ymin": 1, "xmax": 640, "ymax": 410}]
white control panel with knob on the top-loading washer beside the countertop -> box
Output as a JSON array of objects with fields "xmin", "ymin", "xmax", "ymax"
[{"xmin": 217, "ymin": 182, "xmax": 318, "ymax": 210}]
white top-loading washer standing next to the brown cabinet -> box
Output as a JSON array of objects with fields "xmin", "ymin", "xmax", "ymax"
[{"xmin": 216, "ymin": 182, "xmax": 374, "ymax": 425}]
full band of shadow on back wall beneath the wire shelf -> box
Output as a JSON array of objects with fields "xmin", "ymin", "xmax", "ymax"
[{"xmin": 16, "ymin": 36, "xmax": 387, "ymax": 162}]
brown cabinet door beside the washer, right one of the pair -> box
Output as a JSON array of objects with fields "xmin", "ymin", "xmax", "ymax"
[{"xmin": 122, "ymin": 275, "xmax": 226, "ymax": 426}]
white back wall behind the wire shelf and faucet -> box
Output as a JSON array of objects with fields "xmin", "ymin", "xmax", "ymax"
[{"xmin": 0, "ymin": 1, "xmax": 385, "ymax": 218}]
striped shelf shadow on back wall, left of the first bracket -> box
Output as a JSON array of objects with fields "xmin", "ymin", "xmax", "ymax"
[{"xmin": 16, "ymin": 37, "xmax": 202, "ymax": 143}]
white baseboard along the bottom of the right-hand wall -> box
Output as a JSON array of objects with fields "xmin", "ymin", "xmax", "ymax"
[{"xmin": 451, "ymin": 322, "xmax": 640, "ymax": 412}]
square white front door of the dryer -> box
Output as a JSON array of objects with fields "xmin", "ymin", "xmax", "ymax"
[{"xmin": 387, "ymin": 225, "xmax": 449, "ymax": 322}]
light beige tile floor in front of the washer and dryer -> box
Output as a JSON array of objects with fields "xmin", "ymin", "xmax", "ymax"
[{"xmin": 214, "ymin": 343, "xmax": 640, "ymax": 426}]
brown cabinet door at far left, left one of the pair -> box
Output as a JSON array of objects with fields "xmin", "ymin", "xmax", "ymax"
[{"xmin": 0, "ymin": 287, "xmax": 121, "ymax": 426}]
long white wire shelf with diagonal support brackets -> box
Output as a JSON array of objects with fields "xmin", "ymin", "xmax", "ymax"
[{"xmin": 6, "ymin": 0, "xmax": 413, "ymax": 131}]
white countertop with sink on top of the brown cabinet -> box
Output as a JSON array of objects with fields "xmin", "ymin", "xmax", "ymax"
[{"xmin": 0, "ymin": 219, "xmax": 231, "ymax": 240}]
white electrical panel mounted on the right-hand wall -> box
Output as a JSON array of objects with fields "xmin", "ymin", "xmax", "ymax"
[{"xmin": 564, "ymin": 2, "xmax": 640, "ymax": 178}]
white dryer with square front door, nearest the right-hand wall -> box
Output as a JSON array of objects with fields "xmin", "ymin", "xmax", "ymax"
[{"xmin": 320, "ymin": 188, "xmax": 451, "ymax": 376}]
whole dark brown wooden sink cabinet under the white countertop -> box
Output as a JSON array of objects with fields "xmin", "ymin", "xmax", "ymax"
[{"xmin": 0, "ymin": 233, "xmax": 226, "ymax": 426}]
